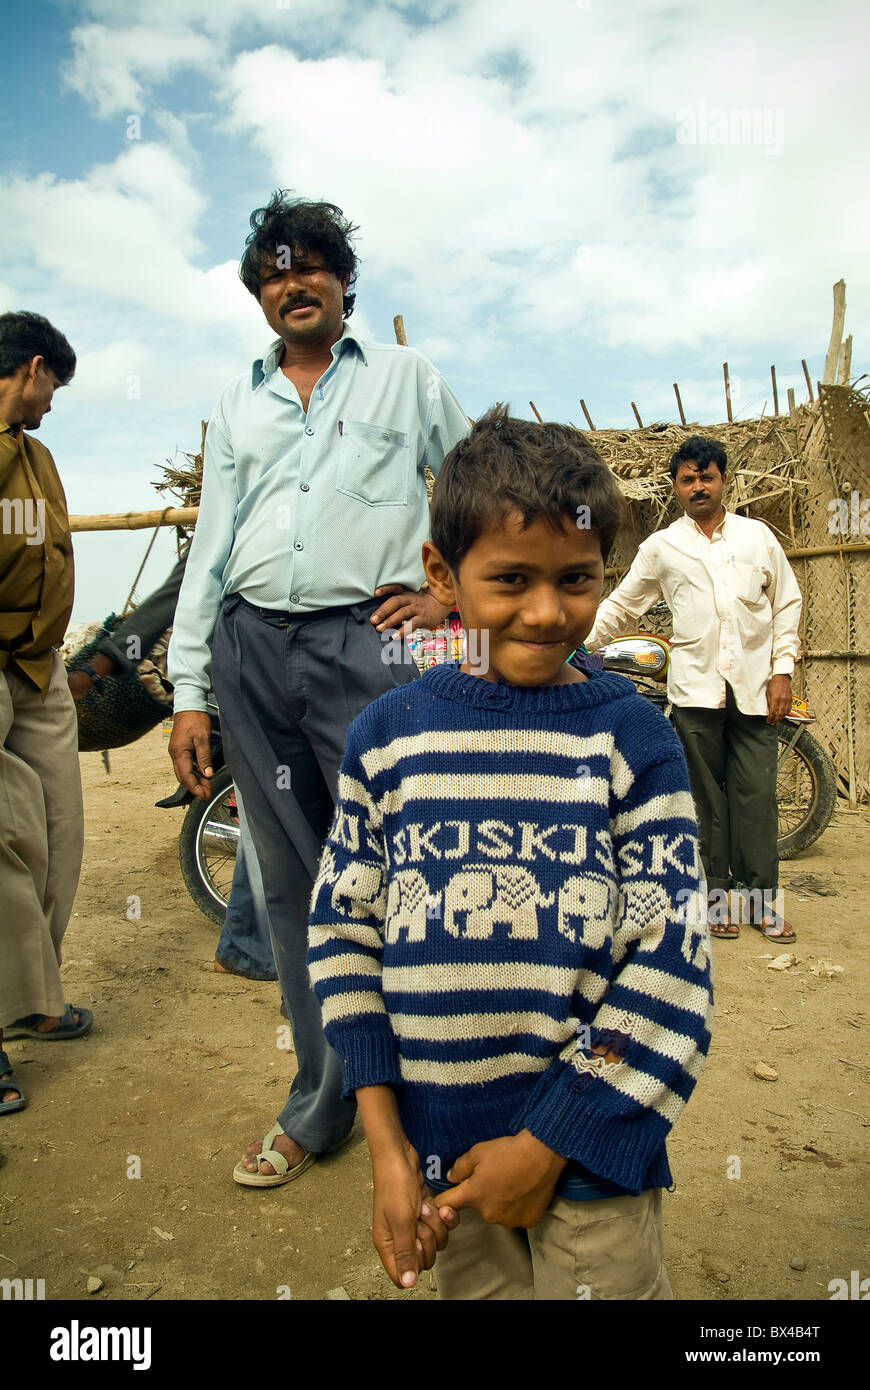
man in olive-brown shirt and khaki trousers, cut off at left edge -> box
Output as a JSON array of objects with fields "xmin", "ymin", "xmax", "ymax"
[{"xmin": 0, "ymin": 313, "xmax": 93, "ymax": 1113}]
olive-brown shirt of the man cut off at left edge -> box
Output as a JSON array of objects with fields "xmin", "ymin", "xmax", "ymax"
[{"xmin": 0, "ymin": 416, "xmax": 74, "ymax": 699}]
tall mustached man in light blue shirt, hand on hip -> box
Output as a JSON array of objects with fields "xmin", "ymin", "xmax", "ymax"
[{"xmin": 170, "ymin": 193, "xmax": 468, "ymax": 1187}]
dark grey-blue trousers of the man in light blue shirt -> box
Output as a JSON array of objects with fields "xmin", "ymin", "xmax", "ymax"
[{"xmin": 211, "ymin": 594, "xmax": 418, "ymax": 1154}]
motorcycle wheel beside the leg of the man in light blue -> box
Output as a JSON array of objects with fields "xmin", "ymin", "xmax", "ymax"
[{"xmin": 178, "ymin": 767, "xmax": 239, "ymax": 926}]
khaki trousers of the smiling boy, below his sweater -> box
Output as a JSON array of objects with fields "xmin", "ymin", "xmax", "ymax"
[{"xmin": 435, "ymin": 1187, "xmax": 674, "ymax": 1301}]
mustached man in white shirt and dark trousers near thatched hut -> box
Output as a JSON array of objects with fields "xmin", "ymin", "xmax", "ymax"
[{"xmin": 586, "ymin": 435, "xmax": 802, "ymax": 945}]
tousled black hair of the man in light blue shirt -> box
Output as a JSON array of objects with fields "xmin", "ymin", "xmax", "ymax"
[{"xmin": 239, "ymin": 188, "xmax": 359, "ymax": 318}]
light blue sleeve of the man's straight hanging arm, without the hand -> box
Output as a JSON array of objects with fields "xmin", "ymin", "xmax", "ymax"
[{"xmin": 168, "ymin": 406, "xmax": 239, "ymax": 714}]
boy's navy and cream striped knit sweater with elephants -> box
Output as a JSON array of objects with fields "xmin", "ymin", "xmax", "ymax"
[{"xmin": 309, "ymin": 666, "xmax": 712, "ymax": 1193}]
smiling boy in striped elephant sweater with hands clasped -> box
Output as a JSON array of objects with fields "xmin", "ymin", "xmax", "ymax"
[{"xmin": 309, "ymin": 406, "xmax": 712, "ymax": 1300}]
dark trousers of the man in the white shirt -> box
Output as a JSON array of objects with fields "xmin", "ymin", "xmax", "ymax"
[{"xmin": 673, "ymin": 685, "xmax": 780, "ymax": 894}]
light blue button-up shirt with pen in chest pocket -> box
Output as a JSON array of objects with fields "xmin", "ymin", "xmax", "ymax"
[{"xmin": 170, "ymin": 324, "xmax": 468, "ymax": 713}]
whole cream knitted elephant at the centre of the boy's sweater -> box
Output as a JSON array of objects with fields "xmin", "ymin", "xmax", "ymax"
[{"xmin": 443, "ymin": 865, "xmax": 556, "ymax": 941}]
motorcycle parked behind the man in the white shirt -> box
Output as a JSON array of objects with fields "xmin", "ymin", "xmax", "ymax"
[{"xmin": 596, "ymin": 632, "xmax": 837, "ymax": 859}]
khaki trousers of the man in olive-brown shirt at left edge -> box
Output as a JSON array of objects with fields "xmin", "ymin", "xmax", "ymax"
[{"xmin": 0, "ymin": 652, "xmax": 85, "ymax": 1027}]
